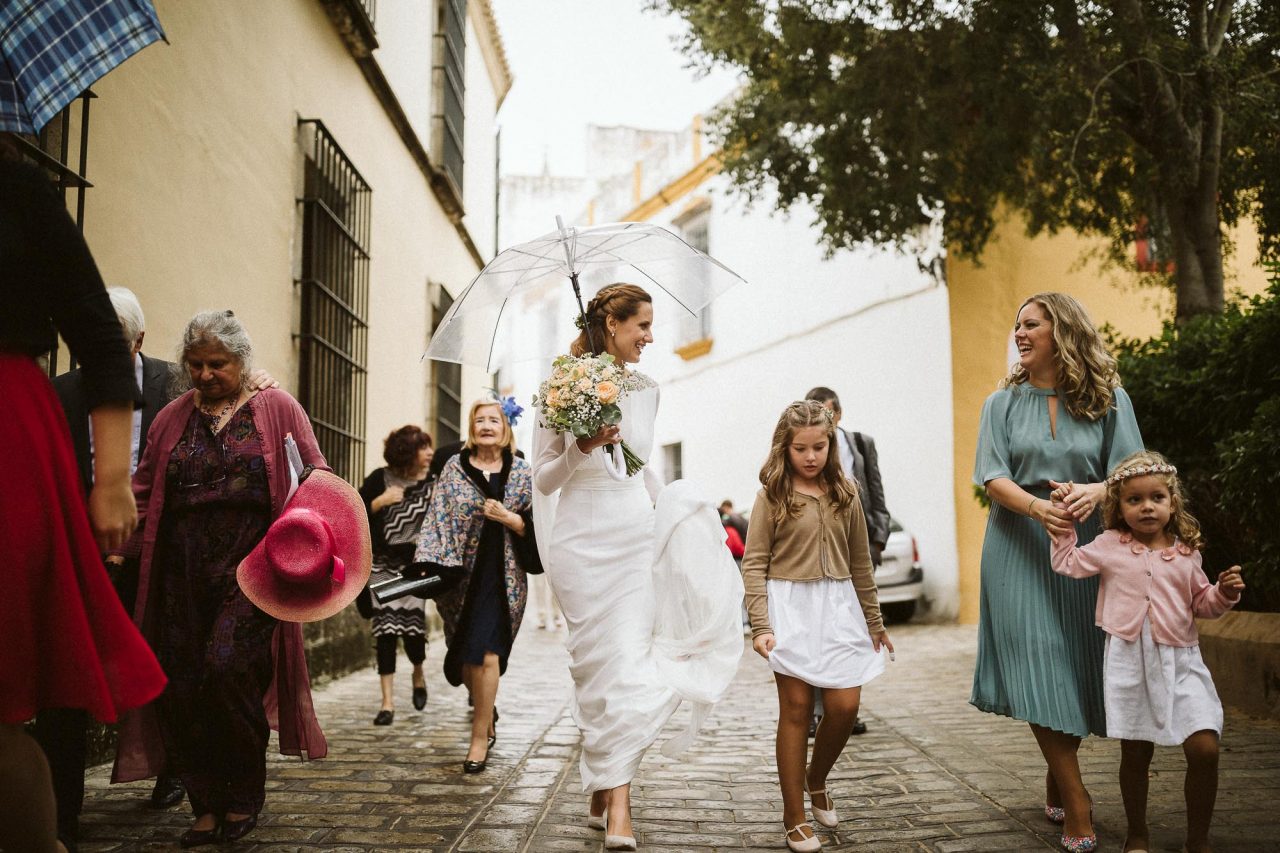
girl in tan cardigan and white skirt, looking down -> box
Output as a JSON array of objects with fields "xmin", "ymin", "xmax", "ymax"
[{"xmin": 742, "ymin": 401, "xmax": 893, "ymax": 852}]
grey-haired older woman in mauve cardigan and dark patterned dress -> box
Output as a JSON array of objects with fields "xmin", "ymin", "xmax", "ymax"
[{"xmin": 113, "ymin": 311, "xmax": 328, "ymax": 847}]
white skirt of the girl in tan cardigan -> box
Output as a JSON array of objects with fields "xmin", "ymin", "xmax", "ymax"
[{"xmin": 767, "ymin": 578, "xmax": 884, "ymax": 689}]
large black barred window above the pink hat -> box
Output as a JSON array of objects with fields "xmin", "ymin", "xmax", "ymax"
[{"xmin": 297, "ymin": 119, "xmax": 372, "ymax": 483}]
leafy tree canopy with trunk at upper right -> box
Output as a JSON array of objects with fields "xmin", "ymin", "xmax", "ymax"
[{"xmin": 650, "ymin": 0, "xmax": 1280, "ymax": 319}]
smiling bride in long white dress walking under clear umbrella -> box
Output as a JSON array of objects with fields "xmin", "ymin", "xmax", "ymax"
[{"xmin": 534, "ymin": 284, "xmax": 741, "ymax": 850}]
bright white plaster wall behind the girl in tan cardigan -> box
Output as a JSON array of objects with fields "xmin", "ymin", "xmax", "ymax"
[{"xmin": 640, "ymin": 178, "xmax": 959, "ymax": 617}]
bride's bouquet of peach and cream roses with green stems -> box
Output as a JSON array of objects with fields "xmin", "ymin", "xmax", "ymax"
[{"xmin": 534, "ymin": 353, "xmax": 644, "ymax": 476}]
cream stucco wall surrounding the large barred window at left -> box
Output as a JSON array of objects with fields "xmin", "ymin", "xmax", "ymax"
[{"xmin": 68, "ymin": 0, "xmax": 493, "ymax": 479}]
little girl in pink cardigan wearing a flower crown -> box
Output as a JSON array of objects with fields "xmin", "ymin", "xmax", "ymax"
[{"xmin": 1051, "ymin": 451, "xmax": 1244, "ymax": 853}]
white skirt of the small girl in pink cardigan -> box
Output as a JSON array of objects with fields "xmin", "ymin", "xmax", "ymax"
[{"xmin": 1102, "ymin": 619, "xmax": 1222, "ymax": 747}]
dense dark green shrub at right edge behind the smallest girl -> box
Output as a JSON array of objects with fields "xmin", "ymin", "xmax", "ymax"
[{"xmin": 1111, "ymin": 266, "xmax": 1280, "ymax": 611}]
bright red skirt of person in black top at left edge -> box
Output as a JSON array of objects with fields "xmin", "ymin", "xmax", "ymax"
[{"xmin": 0, "ymin": 353, "xmax": 165, "ymax": 724}]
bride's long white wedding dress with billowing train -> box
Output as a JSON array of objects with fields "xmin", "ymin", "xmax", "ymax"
[{"xmin": 534, "ymin": 373, "xmax": 742, "ymax": 792}]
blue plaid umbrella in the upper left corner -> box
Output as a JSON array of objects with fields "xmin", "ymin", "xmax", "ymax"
[{"xmin": 0, "ymin": 0, "xmax": 164, "ymax": 133}]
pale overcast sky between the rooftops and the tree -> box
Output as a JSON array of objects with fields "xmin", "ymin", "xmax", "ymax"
[{"xmin": 493, "ymin": 0, "xmax": 735, "ymax": 175}]
